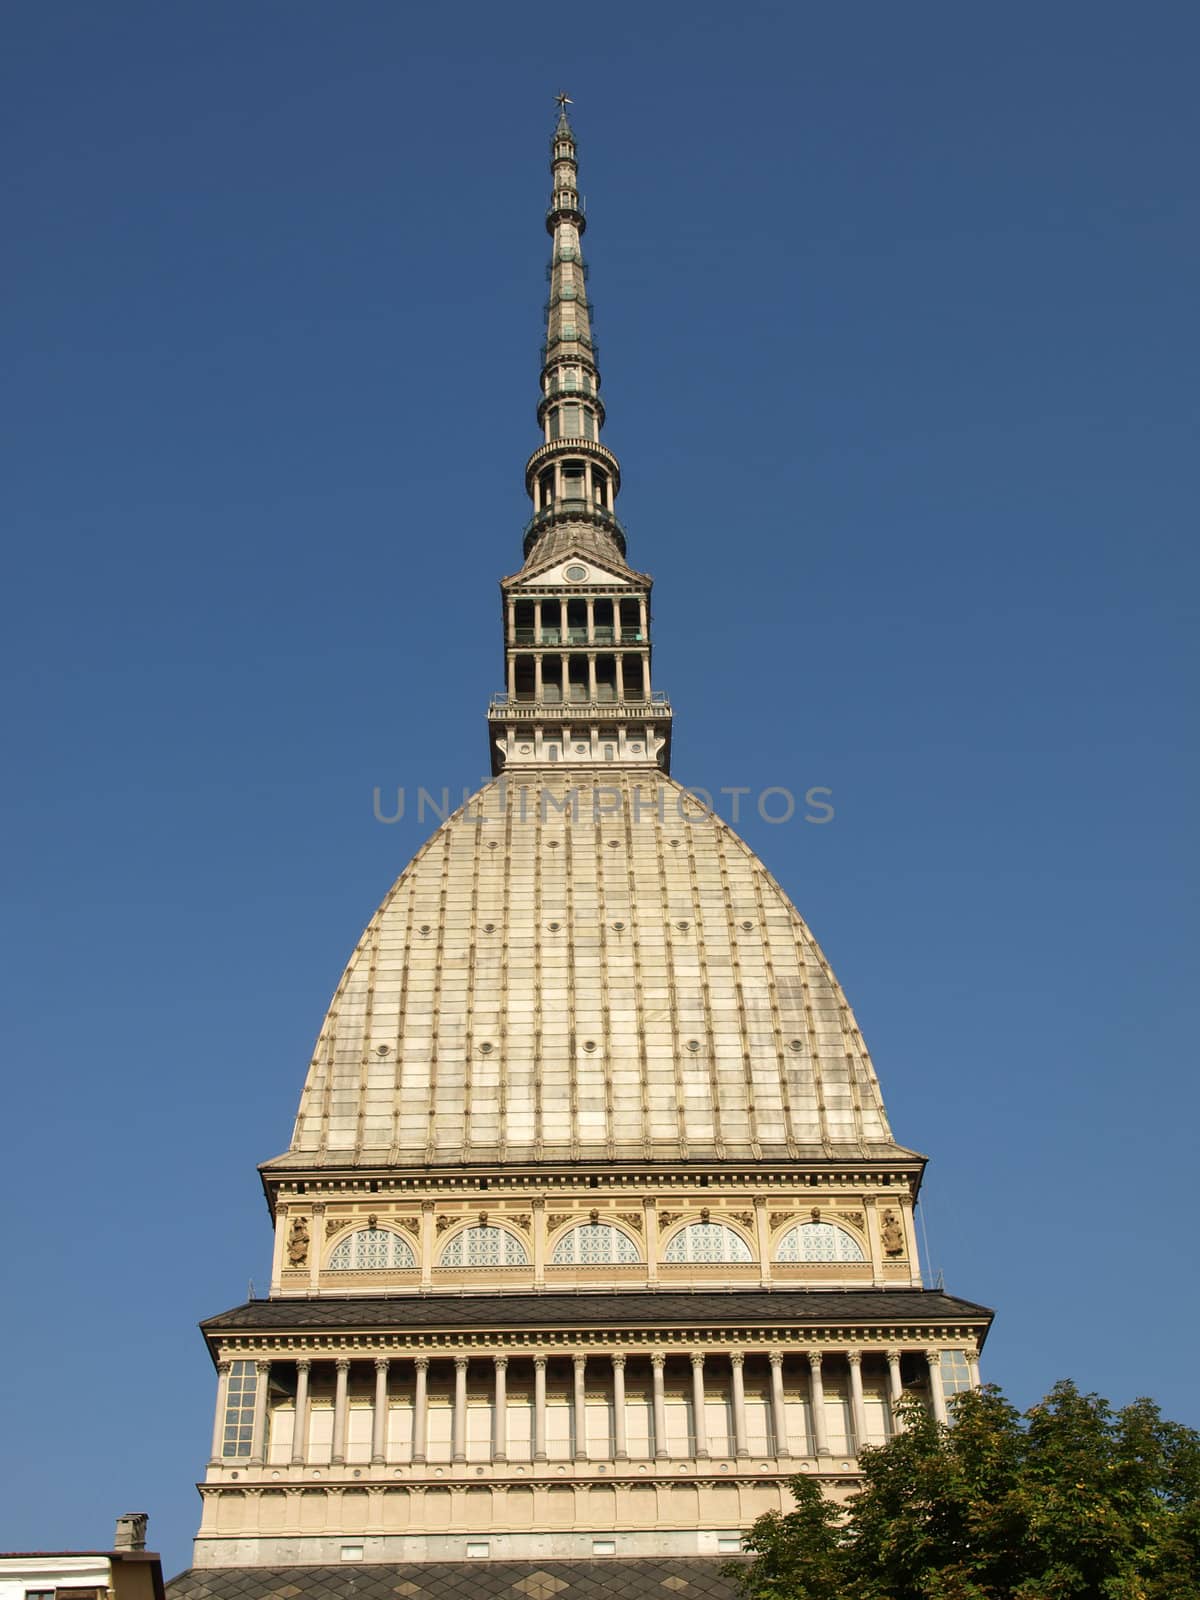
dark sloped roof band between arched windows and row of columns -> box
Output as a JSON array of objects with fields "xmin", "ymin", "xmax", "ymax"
[{"xmin": 200, "ymin": 1290, "xmax": 994, "ymax": 1333}]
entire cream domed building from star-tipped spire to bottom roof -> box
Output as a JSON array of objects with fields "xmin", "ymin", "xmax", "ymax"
[{"xmin": 173, "ymin": 106, "xmax": 990, "ymax": 1600}]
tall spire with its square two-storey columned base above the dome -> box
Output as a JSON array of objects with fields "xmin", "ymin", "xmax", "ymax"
[{"xmin": 488, "ymin": 94, "xmax": 670, "ymax": 773}]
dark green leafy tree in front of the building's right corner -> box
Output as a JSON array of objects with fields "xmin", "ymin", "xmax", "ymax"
[{"xmin": 728, "ymin": 1382, "xmax": 1200, "ymax": 1600}]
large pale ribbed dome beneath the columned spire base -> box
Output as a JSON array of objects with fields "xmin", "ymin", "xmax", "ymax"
[{"xmin": 269, "ymin": 771, "xmax": 896, "ymax": 1168}]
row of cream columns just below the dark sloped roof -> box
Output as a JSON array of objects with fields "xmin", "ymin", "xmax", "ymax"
[{"xmin": 211, "ymin": 1349, "xmax": 979, "ymax": 1466}]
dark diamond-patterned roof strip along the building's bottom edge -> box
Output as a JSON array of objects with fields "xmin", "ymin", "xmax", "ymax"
[{"xmin": 166, "ymin": 1557, "xmax": 736, "ymax": 1600}]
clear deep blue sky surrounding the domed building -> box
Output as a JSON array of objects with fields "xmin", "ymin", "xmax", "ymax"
[{"xmin": 0, "ymin": 0, "xmax": 1200, "ymax": 1570}]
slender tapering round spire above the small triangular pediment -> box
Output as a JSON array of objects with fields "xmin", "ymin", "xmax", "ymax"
[{"xmin": 525, "ymin": 94, "xmax": 626, "ymax": 562}]
